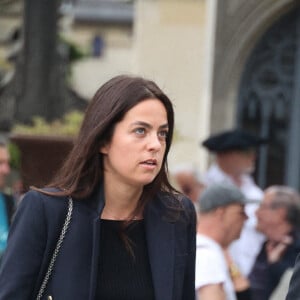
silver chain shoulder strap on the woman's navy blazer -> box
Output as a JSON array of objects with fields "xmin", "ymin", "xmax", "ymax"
[{"xmin": 36, "ymin": 197, "xmax": 73, "ymax": 300}]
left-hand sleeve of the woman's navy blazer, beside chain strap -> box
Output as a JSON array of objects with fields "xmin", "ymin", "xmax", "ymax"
[{"xmin": 0, "ymin": 192, "xmax": 47, "ymax": 300}]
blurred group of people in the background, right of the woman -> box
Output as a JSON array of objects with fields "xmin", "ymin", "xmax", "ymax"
[{"xmin": 173, "ymin": 129, "xmax": 300, "ymax": 300}]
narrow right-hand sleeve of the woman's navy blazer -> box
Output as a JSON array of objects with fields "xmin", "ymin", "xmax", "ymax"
[{"xmin": 183, "ymin": 198, "xmax": 196, "ymax": 300}]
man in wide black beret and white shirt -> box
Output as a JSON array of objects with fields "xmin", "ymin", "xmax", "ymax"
[{"xmin": 202, "ymin": 129, "xmax": 266, "ymax": 276}]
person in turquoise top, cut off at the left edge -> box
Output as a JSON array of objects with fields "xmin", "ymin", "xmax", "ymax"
[{"xmin": 0, "ymin": 140, "xmax": 15, "ymax": 260}]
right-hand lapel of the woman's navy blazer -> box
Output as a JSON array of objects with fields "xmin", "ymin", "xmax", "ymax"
[{"xmin": 145, "ymin": 199, "xmax": 175, "ymax": 300}]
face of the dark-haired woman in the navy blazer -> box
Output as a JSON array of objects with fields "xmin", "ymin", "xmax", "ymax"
[{"xmin": 100, "ymin": 98, "xmax": 168, "ymax": 186}]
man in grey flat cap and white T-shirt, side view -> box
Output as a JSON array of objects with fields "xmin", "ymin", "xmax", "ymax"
[{"xmin": 195, "ymin": 184, "xmax": 251, "ymax": 300}]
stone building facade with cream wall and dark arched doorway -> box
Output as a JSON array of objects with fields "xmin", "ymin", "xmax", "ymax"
[{"xmin": 136, "ymin": 0, "xmax": 300, "ymax": 187}]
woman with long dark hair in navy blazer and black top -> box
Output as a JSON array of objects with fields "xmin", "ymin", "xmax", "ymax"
[{"xmin": 0, "ymin": 76, "xmax": 196, "ymax": 300}]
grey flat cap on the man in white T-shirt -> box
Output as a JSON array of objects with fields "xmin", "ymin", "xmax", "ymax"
[{"xmin": 198, "ymin": 183, "xmax": 250, "ymax": 212}]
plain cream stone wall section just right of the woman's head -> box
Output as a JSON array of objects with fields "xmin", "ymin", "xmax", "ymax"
[{"xmin": 134, "ymin": 0, "xmax": 210, "ymax": 169}]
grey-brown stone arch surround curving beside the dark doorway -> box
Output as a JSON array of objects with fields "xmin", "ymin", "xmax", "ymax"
[{"xmin": 211, "ymin": 0, "xmax": 295, "ymax": 132}]
